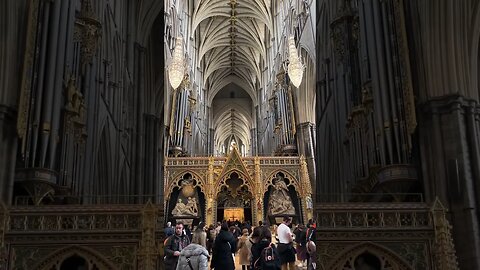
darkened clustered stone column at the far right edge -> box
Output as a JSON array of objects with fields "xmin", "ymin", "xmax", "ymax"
[{"xmin": 419, "ymin": 95, "xmax": 480, "ymax": 269}]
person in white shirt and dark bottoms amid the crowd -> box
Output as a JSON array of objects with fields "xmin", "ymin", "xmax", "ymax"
[{"xmin": 277, "ymin": 216, "xmax": 296, "ymax": 270}]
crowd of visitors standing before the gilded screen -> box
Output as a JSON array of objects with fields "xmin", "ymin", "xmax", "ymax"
[{"xmin": 164, "ymin": 216, "xmax": 316, "ymax": 270}]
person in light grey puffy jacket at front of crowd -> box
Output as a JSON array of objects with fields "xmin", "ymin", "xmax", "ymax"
[{"xmin": 176, "ymin": 243, "xmax": 210, "ymax": 270}]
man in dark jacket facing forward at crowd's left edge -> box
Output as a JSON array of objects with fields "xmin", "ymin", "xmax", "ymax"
[{"xmin": 165, "ymin": 222, "xmax": 190, "ymax": 270}]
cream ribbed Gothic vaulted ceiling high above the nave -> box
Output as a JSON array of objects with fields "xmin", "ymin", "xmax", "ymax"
[{"xmin": 192, "ymin": 0, "xmax": 273, "ymax": 153}]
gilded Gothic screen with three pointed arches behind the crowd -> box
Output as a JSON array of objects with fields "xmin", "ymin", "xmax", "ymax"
[{"xmin": 164, "ymin": 155, "xmax": 313, "ymax": 224}]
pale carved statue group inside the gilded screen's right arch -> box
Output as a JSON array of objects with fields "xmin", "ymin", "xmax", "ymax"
[{"xmin": 268, "ymin": 175, "xmax": 295, "ymax": 216}]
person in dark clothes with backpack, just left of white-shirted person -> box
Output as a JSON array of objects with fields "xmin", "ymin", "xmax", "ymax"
[{"xmin": 252, "ymin": 226, "xmax": 281, "ymax": 270}]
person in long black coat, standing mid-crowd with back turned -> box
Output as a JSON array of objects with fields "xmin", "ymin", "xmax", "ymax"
[{"xmin": 210, "ymin": 223, "xmax": 237, "ymax": 270}]
